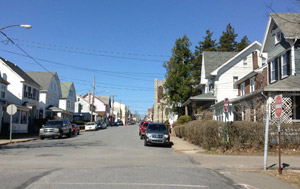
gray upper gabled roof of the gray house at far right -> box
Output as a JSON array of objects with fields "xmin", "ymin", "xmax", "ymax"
[{"xmin": 270, "ymin": 13, "xmax": 300, "ymax": 39}]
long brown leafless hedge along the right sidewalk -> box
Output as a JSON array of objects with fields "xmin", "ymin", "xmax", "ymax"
[{"xmin": 174, "ymin": 120, "xmax": 300, "ymax": 151}]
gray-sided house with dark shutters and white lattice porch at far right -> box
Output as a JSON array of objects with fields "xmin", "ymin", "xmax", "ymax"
[{"xmin": 261, "ymin": 13, "xmax": 300, "ymax": 123}]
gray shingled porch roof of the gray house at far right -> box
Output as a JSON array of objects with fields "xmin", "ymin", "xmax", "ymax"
[{"xmin": 264, "ymin": 75, "xmax": 300, "ymax": 92}]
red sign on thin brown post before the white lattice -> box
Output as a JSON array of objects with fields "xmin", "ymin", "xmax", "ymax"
[{"xmin": 275, "ymin": 95, "xmax": 282, "ymax": 174}]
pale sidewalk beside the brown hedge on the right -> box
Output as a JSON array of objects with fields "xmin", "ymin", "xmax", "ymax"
[{"xmin": 171, "ymin": 136, "xmax": 300, "ymax": 189}]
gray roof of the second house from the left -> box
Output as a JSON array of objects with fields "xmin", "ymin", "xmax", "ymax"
[{"xmin": 26, "ymin": 72, "xmax": 58, "ymax": 90}]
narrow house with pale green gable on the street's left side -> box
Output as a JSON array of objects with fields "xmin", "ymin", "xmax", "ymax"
[{"xmin": 59, "ymin": 82, "xmax": 76, "ymax": 121}]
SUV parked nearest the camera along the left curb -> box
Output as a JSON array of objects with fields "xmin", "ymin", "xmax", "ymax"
[{"xmin": 39, "ymin": 120, "xmax": 72, "ymax": 140}]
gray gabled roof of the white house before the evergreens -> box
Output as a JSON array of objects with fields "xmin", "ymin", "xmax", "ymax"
[{"xmin": 203, "ymin": 51, "xmax": 237, "ymax": 78}]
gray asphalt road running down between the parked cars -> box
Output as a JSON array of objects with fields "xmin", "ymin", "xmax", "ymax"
[{"xmin": 0, "ymin": 125, "xmax": 238, "ymax": 189}]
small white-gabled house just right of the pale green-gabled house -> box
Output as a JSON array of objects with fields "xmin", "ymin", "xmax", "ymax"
[{"xmin": 73, "ymin": 95, "xmax": 98, "ymax": 121}]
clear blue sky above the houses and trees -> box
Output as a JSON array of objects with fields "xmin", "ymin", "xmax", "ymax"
[{"xmin": 0, "ymin": 0, "xmax": 299, "ymax": 115}]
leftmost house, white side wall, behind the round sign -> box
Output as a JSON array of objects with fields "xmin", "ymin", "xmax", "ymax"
[{"xmin": 0, "ymin": 58, "xmax": 41, "ymax": 133}]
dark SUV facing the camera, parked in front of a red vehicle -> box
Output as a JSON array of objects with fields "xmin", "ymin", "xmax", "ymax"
[{"xmin": 144, "ymin": 123, "xmax": 170, "ymax": 146}]
